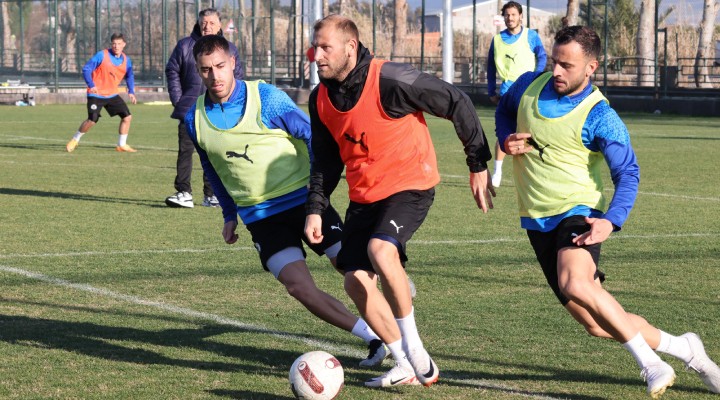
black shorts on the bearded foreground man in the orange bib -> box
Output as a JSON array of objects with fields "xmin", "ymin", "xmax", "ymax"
[{"xmin": 337, "ymin": 189, "xmax": 435, "ymax": 271}]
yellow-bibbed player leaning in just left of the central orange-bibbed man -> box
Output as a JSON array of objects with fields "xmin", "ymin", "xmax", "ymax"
[{"xmin": 185, "ymin": 35, "xmax": 386, "ymax": 366}]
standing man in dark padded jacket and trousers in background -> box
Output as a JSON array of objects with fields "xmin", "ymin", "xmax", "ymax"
[{"xmin": 165, "ymin": 8, "xmax": 245, "ymax": 208}]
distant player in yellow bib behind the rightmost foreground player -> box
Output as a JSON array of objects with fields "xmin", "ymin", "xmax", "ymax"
[{"xmin": 487, "ymin": 1, "xmax": 547, "ymax": 187}]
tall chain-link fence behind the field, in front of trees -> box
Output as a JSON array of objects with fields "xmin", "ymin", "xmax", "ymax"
[{"xmin": 0, "ymin": 0, "xmax": 720, "ymax": 90}]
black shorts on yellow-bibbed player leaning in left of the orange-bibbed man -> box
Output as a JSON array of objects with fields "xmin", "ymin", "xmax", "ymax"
[{"xmin": 245, "ymin": 204, "xmax": 342, "ymax": 271}]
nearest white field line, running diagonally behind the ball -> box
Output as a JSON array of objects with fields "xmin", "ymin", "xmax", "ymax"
[{"xmin": 0, "ymin": 265, "xmax": 556, "ymax": 400}]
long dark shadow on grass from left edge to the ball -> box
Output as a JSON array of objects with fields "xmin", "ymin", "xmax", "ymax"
[{"xmin": 0, "ymin": 315, "xmax": 298, "ymax": 377}]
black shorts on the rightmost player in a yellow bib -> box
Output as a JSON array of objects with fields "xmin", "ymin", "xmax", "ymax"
[{"xmin": 527, "ymin": 215, "xmax": 605, "ymax": 305}]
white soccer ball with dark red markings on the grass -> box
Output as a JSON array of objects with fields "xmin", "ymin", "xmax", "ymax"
[{"xmin": 290, "ymin": 351, "xmax": 345, "ymax": 400}]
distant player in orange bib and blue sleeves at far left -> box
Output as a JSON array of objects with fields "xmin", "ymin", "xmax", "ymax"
[{"xmin": 65, "ymin": 33, "xmax": 137, "ymax": 153}]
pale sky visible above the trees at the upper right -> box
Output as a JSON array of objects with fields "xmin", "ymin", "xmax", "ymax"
[{"xmin": 407, "ymin": 0, "xmax": 720, "ymax": 24}]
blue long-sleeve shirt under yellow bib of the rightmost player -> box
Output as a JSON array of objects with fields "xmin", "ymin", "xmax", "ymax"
[{"xmin": 495, "ymin": 72, "xmax": 640, "ymax": 232}]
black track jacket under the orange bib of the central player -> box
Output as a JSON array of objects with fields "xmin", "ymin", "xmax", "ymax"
[{"xmin": 306, "ymin": 44, "xmax": 492, "ymax": 214}]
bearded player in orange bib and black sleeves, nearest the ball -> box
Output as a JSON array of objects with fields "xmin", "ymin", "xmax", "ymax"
[{"xmin": 305, "ymin": 15, "xmax": 494, "ymax": 387}]
